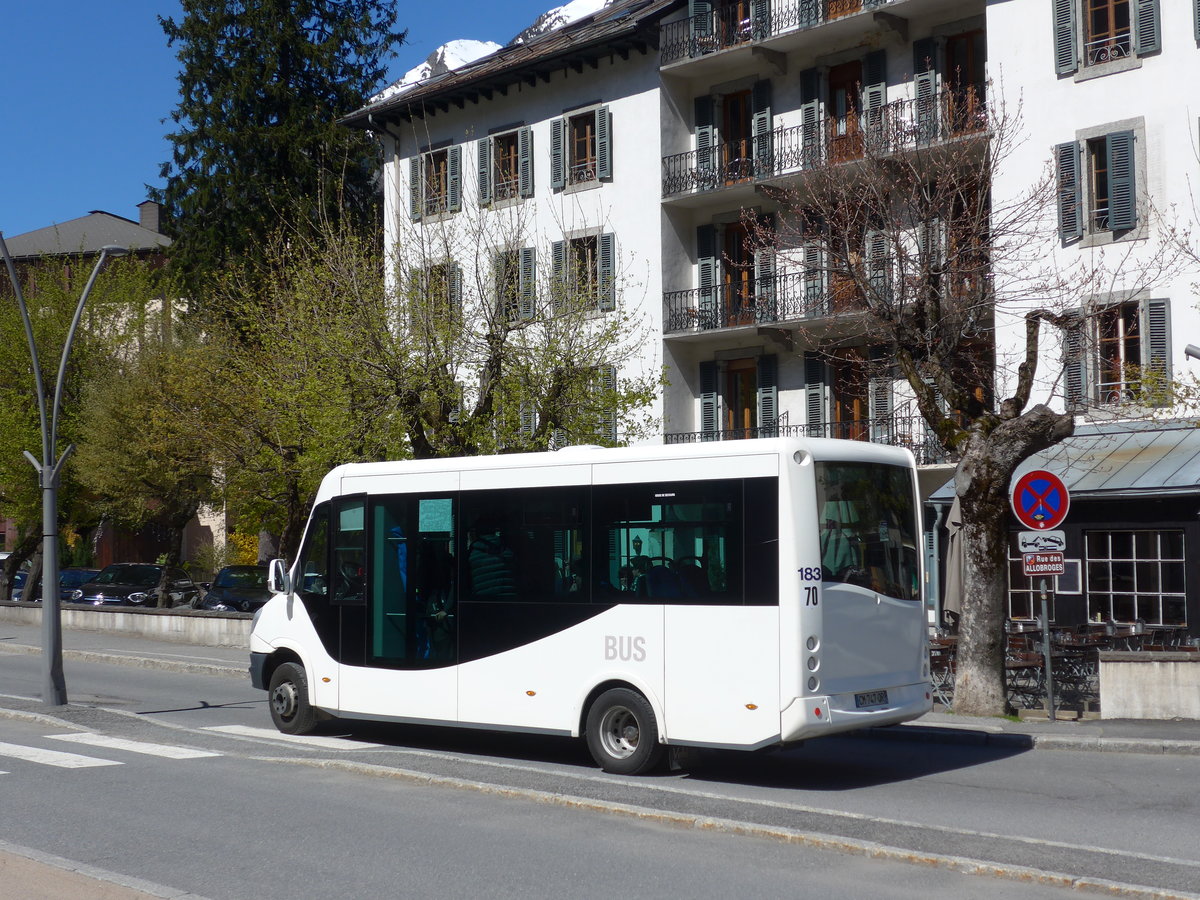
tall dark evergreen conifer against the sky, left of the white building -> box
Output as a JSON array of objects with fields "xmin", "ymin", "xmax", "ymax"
[{"xmin": 157, "ymin": 0, "xmax": 406, "ymax": 292}]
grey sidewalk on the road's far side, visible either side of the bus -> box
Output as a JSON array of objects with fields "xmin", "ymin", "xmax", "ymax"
[{"xmin": 7, "ymin": 622, "xmax": 1200, "ymax": 756}]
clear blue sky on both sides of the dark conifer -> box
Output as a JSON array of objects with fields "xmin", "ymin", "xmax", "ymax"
[{"xmin": 0, "ymin": 0, "xmax": 552, "ymax": 236}]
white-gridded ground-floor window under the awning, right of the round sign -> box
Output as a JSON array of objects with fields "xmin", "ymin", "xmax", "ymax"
[{"xmin": 1084, "ymin": 529, "xmax": 1187, "ymax": 625}]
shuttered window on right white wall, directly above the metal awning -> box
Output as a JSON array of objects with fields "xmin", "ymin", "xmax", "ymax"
[{"xmin": 1066, "ymin": 299, "xmax": 1170, "ymax": 408}]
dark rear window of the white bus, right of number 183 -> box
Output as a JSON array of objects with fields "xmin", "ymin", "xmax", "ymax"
[{"xmin": 816, "ymin": 462, "xmax": 920, "ymax": 600}]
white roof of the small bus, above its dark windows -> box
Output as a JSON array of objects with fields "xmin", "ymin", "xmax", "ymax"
[{"xmin": 316, "ymin": 438, "xmax": 916, "ymax": 503}]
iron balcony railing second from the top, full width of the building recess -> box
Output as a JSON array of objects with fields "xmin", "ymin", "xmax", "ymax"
[{"xmin": 662, "ymin": 88, "xmax": 988, "ymax": 197}]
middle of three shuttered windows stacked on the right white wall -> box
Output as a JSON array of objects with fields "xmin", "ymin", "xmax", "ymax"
[{"xmin": 1055, "ymin": 131, "xmax": 1138, "ymax": 244}]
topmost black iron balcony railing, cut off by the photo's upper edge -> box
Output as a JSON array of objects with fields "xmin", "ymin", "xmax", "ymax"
[{"xmin": 659, "ymin": 0, "xmax": 892, "ymax": 66}]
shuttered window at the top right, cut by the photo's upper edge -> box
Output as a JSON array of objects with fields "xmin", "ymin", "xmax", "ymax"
[{"xmin": 1054, "ymin": 0, "xmax": 1162, "ymax": 74}]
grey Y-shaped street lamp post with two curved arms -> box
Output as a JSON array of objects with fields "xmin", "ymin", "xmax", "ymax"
[{"xmin": 0, "ymin": 233, "xmax": 128, "ymax": 707}]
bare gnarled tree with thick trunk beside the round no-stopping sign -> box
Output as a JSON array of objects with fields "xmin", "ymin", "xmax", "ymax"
[{"xmin": 755, "ymin": 95, "xmax": 1164, "ymax": 715}]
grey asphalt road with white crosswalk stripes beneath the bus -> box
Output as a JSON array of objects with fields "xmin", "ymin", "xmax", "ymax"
[{"xmin": 0, "ymin": 648, "xmax": 1200, "ymax": 900}]
